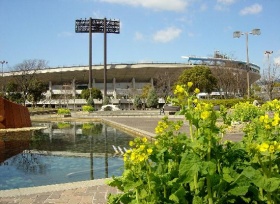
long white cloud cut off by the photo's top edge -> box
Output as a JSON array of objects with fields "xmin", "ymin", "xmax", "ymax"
[{"xmin": 100, "ymin": 0, "xmax": 191, "ymax": 11}]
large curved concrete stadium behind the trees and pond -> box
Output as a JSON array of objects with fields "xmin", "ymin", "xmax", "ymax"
[{"xmin": 2, "ymin": 56, "xmax": 260, "ymax": 110}]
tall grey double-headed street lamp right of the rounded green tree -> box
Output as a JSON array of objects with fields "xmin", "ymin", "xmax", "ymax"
[{"xmin": 233, "ymin": 29, "xmax": 261, "ymax": 99}]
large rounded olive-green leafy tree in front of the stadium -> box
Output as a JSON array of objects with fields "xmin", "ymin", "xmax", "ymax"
[{"xmin": 176, "ymin": 66, "xmax": 217, "ymax": 93}]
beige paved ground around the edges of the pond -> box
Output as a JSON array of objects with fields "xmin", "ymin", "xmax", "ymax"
[{"xmin": 0, "ymin": 114, "xmax": 241, "ymax": 204}]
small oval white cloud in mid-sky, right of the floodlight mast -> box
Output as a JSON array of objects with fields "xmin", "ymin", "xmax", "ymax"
[{"xmin": 153, "ymin": 27, "xmax": 182, "ymax": 43}]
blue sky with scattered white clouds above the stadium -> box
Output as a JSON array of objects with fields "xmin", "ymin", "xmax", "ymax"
[{"xmin": 0, "ymin": 0, "xmax": 280, "ymax": 70}]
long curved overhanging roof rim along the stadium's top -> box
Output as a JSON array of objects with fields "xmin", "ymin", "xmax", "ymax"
[{"xmin": 3, "ymin": 57, "xmax": 260, "ymax": 84}]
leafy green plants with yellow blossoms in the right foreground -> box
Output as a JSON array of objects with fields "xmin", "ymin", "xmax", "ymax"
[{"xmin": 109, "ymin": 84, "xmax": 280, "ymax": 204}]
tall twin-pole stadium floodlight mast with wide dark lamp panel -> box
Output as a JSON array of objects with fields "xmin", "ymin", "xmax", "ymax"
[{"xmin": 75, "ymin": 18, "xmax": 120, "ymax": 97}]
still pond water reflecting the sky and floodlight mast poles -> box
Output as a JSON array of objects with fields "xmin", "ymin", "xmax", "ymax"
[{"xmin": 0, "ymin": 122, "xmax": 133, "ymax": 190}]
